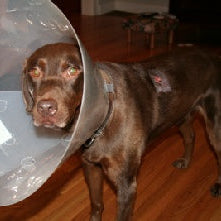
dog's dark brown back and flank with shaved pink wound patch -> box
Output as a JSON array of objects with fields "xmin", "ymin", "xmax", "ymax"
[{"xmin": 101, "ymin": 49, "xmax": 221, "ymax": 139}]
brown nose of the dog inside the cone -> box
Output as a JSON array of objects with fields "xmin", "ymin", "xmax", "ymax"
[{"xmin": 37, "ymin": 99, "xmax": 58, "ymax": 116}]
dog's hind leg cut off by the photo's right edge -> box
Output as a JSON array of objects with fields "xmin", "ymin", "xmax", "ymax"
[{"xmin": 202, "ymin": 90, "xmax": 221, "ymax": 197}]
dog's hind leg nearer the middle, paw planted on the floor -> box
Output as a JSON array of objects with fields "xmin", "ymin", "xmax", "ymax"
[{"xmin": 173, "ymin": 114, "xmax": 195, "ymax": 169}]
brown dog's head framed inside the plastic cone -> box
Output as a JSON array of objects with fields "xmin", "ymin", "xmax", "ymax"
[{"xmin": 23, "ymin": 43, "xmax": 83, "ymax": 128}]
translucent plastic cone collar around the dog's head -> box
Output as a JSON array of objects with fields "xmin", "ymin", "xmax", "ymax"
[{"xmin": 0, "ymin": 0, "xmax": 109, "ymax": 206}]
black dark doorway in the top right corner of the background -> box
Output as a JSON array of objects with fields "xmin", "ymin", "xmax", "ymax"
[{"xmin": 170, "ymin": 0, "xmax": 221, "ymax": 45}]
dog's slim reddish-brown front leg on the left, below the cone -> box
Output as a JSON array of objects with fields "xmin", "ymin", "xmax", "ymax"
[{"xmin": 83, "ymin": 160, "xmax": 104, "ymax": 221}]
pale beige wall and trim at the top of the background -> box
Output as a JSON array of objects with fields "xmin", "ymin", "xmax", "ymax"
[{"xmin": 81, "ymin": 0, "xmax": 169, "ymax": 15}]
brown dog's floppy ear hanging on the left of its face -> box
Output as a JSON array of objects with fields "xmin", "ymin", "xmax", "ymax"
[{"xmin": 22, "ymin": 59, "xmax": 34, "ymax": 112}]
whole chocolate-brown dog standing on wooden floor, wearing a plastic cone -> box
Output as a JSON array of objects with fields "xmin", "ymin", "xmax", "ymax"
[{"xmin": 23, "ymin": 43, "xmax": 221, "ymax": 221}]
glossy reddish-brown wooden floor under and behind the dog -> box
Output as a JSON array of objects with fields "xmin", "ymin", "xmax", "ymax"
[{"xmin": 0, "ymin": 13, "xmax": 221, "ymax": 221}]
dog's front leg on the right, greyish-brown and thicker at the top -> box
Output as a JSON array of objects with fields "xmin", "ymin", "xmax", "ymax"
[{"xmin": 103, "ymin": 150, "xmax": 140, "ymax": 221}]
